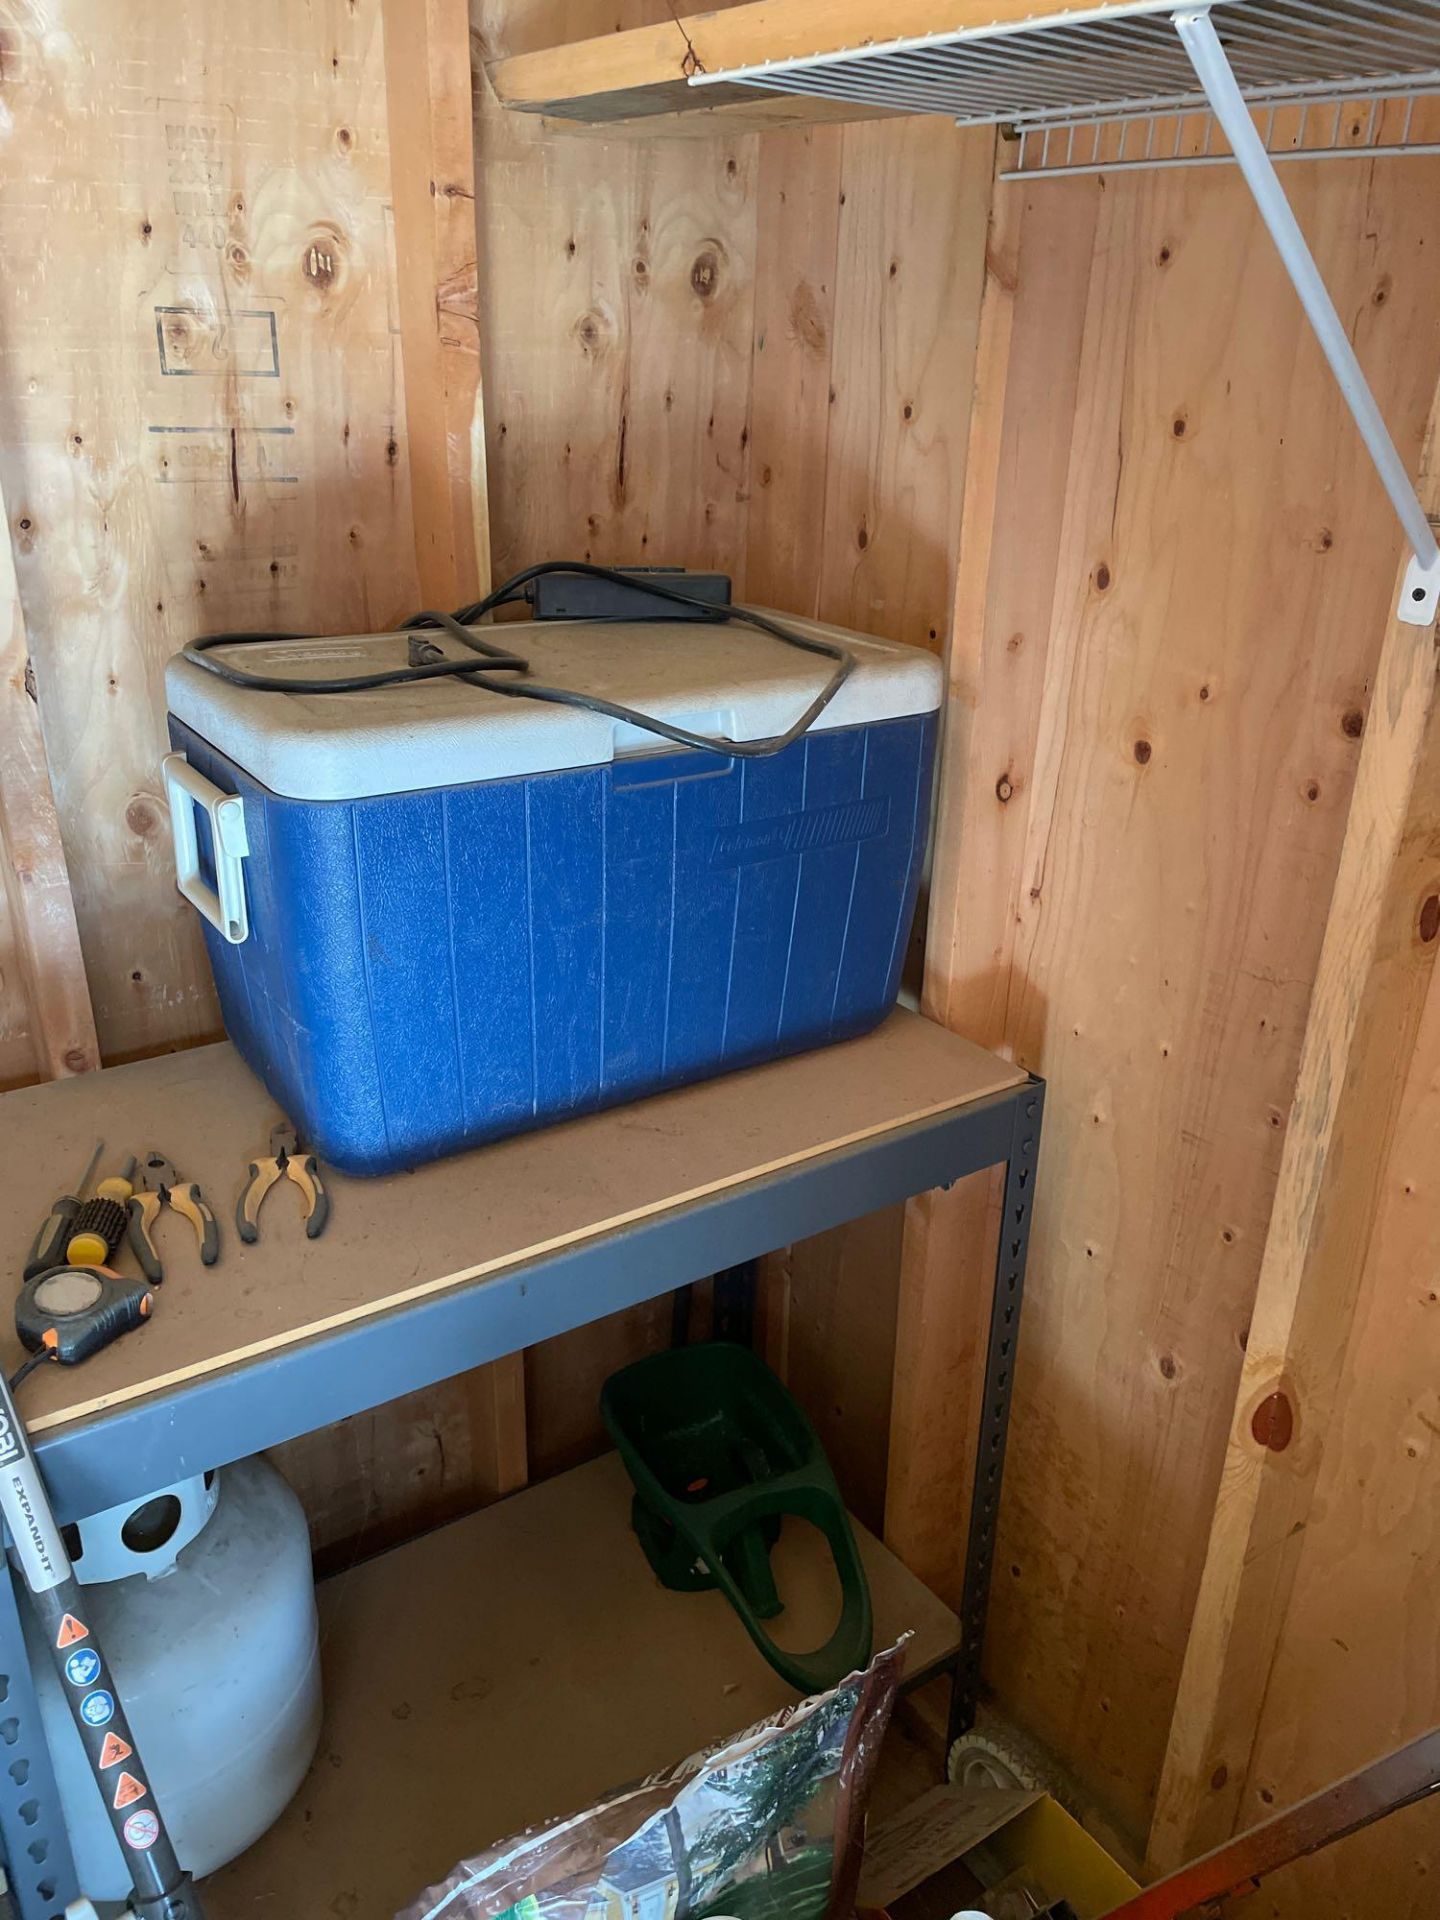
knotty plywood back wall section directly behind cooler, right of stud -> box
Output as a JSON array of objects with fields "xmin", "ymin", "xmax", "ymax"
[{"xmin": 472, "ymin": 0, "xmax": 991, "ymax": 1474}]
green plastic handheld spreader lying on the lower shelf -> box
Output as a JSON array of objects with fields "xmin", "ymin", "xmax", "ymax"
[{"xmin": 601, "ymin": 1340, "xmax": 874, "ymax": 1693}]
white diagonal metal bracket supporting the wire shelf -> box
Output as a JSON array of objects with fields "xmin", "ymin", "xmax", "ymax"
[{"xmin": 1171, "ymin": 8, "xmax": 1440, "ymax": 626}]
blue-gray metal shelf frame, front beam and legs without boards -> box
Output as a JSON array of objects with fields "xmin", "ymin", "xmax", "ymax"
[{"xmin": 0, "ymin": 1077, "xmax": 1044, "ymax": 1920}]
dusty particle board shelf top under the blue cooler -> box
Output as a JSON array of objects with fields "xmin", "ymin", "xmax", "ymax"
[{"xmin": 0, "ymin": 1012, "xmax": 1025, "ymax": 1434}]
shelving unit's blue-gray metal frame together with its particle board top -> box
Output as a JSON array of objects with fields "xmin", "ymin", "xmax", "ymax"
[{"xmin": 0, "ymin": 1014, "xmax": 1044, "ymax": 1920}]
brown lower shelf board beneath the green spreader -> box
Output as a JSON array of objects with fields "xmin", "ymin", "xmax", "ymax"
[{"xmin": 204, "ymin": 1453, "xmax": 960, "ymax": 1920}]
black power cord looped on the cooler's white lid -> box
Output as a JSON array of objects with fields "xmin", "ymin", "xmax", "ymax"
[{"xmin": 182, "ymin": 561, "xmax": 854, "ymax": 758}]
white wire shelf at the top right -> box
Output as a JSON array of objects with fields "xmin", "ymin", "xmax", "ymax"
[{"xmin": 689, "ymin": 0, "xmax": 1440, "ymax": 127}]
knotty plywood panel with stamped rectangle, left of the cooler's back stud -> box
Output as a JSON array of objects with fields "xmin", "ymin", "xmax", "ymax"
[{"xmin": 0, "ymin": 0, "xmax": 432, "ymax": 1060}]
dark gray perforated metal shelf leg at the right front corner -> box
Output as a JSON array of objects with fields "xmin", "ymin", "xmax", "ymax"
[{"xmin": 947, "ymin": 1079, "xmax": 1044, "ymax": 1749}]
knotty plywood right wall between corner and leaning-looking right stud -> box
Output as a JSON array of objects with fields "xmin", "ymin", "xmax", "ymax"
[{"xmin": 906, "ymin": 159, "xmax": 1440, "ymax": 1841}]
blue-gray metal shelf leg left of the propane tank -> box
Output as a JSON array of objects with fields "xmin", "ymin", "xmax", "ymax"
[{"xmin": 0, "ymin": 1563, "xmax": 81, "ymax": 1920}]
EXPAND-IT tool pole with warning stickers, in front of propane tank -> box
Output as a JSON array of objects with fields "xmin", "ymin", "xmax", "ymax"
[{"xmin": 0, "ymin": 1344, "xmax": 202, "ymax": 1920}]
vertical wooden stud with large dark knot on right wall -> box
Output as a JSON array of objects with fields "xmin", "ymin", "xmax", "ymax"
[{"xmin": 1150, "ymin": 401, "xmax": 1440, "ymax": 1870}]
